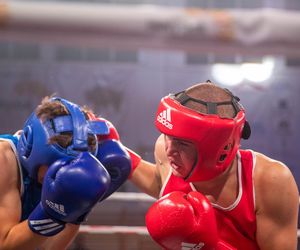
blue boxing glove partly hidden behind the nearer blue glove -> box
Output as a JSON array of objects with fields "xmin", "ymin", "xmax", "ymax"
[{"xmin": 96, "ymin": 139, "xmax": 131, "ymax": 200}]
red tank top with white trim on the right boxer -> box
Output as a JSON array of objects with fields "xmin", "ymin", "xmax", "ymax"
[{"xmin": 160, "ymin": 150, "xmax": 259, "ymax": 250}]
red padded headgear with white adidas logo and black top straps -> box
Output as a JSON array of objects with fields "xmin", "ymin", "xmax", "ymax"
[{"xmin": 155, "ymin": 91, "xmax": 251, "ymax": 182}]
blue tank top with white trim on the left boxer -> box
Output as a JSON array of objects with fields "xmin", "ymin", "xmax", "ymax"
[{"xmin": 0, "ymin": 134, "xmax": 42, "ymax": 221}]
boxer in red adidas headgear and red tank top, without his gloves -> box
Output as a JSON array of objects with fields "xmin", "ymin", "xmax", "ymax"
[{"xmin": 127, "ymin": 82, "xmax": 299, "ymax": 250}]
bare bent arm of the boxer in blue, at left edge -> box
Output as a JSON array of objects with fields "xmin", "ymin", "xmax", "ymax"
[{"xmin": 0, "ymin": 143, "xmax": 47, "ymax": 250}]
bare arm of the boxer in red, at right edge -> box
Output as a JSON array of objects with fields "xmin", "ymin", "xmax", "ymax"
[{"xmin": 254, "ymin": 155, "xmax": 299, "ymax": 250}]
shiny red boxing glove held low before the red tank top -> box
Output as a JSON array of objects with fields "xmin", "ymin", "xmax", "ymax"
[{"xmin": 146, "ymin": 191, "xmax": 234, "ymax": 250}]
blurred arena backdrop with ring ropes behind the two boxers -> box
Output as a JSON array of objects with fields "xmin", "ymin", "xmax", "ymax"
[{"xmin": 0, "ymin": 0, "xmax": 300, "ymax": 250}]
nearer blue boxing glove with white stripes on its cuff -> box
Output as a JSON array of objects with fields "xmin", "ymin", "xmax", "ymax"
[{"xmin": 28, "ymin": 152, "xmax": 110, "ymax": 236}]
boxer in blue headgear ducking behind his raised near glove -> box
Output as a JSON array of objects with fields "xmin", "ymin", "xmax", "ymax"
[{"xmin": 0, "ymin": 98, "xmax": 118, "ymax": 249}]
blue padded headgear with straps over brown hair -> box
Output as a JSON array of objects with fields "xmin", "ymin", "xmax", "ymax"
[{"xmin": 17, "ymin": 97, "xmax": 109, "ymax": 179}]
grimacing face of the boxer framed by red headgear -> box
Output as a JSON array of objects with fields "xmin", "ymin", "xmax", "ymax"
[{"xmin": 165, "ymin": 135, "xmax": 197, "ymax": 178}]
